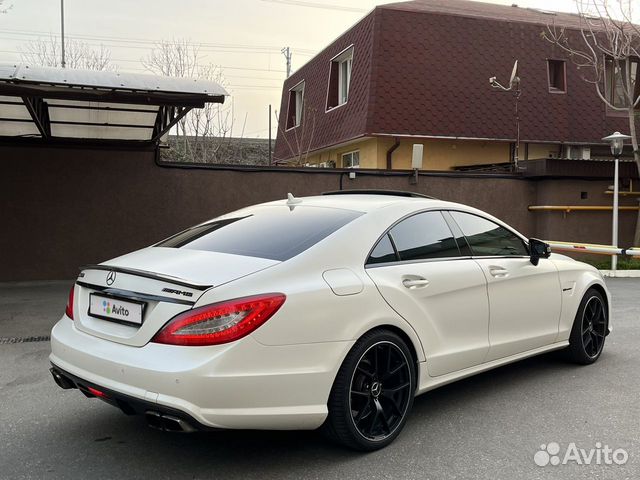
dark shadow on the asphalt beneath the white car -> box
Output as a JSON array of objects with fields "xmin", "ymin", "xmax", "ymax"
[{"xmin": 40, "ymin": 352, "xmax": 575, "ymax": 475}]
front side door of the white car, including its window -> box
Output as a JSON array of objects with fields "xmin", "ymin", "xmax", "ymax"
[{"xmin": 450, "ymin": 212, "xmax": 562, "ymax": 361}]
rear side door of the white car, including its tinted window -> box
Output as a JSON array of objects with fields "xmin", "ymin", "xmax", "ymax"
[{"xmin": 367, "ymin": 211, "xmax": 489, "ymax": 376}]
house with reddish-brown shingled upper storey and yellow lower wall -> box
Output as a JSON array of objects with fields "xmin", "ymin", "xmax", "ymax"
[{"xmin": 274, "ymin": 0, "xmax": 628, "ymax": 170}]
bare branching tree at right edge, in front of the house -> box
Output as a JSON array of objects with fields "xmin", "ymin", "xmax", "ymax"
[{"xmin": 542, "ymin": 0, "xmax": 640, "ymax": 245}]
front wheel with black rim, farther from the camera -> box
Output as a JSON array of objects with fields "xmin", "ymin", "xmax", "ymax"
[{"xmin": 567, "ymin": 288, "xmax": 609, "ymax": 365}]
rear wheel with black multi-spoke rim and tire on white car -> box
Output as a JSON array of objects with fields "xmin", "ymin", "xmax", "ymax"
[{"xmin": 323, "ymin": 329, "xmax": 416, "ymax": 451}]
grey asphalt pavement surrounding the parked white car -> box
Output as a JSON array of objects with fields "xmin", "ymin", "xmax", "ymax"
[{"xmin": 0, "ymin": 279, "xmax": 640, "ymax": 480}]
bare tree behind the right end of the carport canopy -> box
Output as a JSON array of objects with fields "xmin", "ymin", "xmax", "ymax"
[{"xmin": 142, "ymin": 39, "xmax": 234, "ymax": 163}]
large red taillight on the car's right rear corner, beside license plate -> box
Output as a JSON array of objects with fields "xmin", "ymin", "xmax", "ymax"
[{"xmin": 151, "ymin": 293, "xmax": 286, "ymax": 346}]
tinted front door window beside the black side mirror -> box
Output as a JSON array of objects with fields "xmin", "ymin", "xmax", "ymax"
[{"xmin": 451, "ymin": 212, "xmax": 529, "ymax": 256}]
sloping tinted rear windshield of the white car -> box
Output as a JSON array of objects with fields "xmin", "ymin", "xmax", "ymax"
[{"xmin": 155, "ymin": 206, "xmax": 362, "ymax": 261}]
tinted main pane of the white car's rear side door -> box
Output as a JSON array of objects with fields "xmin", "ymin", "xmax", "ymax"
[{"xmin": 389, "ymin": 212, "xmax": 460, "ymax": 260}]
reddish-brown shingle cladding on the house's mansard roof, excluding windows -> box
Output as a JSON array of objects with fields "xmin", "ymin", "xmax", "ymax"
[{"xmin": 275, "ymin": 0, "xmax": 628, "ymax": 158}]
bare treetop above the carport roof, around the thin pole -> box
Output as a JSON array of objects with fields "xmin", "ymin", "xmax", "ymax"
[{"xmin": 20, "ymin": 36, "xmax": 112, "ymax": 70}]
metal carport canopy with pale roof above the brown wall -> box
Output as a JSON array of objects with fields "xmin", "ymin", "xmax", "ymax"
[{"xmin": 0, "ymin": 63, "xmax": 228, "ymax": 145}]
